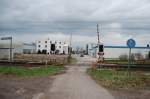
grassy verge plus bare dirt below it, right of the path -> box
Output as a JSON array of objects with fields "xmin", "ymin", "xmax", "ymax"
[{"xmin": 87, "ymin": 68, "xmax": 150, "ymax": 99}]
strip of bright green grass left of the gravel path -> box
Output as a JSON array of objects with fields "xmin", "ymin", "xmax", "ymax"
[{"xmin": 0, "ymin": 66, "xmax": 64, "ymax": 77}]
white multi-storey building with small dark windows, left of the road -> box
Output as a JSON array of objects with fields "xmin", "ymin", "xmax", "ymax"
[{"xmin": 36, "ymin": 38, "xmax": 69, "ymax": 54}]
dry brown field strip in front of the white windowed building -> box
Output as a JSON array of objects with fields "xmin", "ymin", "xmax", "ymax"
[{"xmin": 0, "ymin": 54, "xmax": 69, "ymax": 67}]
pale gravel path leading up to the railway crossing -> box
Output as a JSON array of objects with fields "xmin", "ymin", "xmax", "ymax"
[{"xmin": 37, "ymin": 55, "xmax": 113, "ymax": 99}]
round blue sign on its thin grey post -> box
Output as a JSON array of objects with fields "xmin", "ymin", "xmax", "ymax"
[{"xmin": 127, "ymin": 39, "xmax": 136, "ymax": 75}]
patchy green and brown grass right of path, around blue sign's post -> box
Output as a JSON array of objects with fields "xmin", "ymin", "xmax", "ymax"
[{"xmin": 87, "ymin": 68, "xmax": 150, "ymax": 89}]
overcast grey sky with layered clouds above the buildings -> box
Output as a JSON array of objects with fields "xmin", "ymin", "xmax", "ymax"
[{"xmin": 0, "ymin": 0, "xmax": 150, "ymax": 46}]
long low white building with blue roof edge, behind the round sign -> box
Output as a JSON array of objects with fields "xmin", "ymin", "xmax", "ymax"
[{"xmin": 88, "ymin": 43, "xmax": 150, "ymax": 59}]
